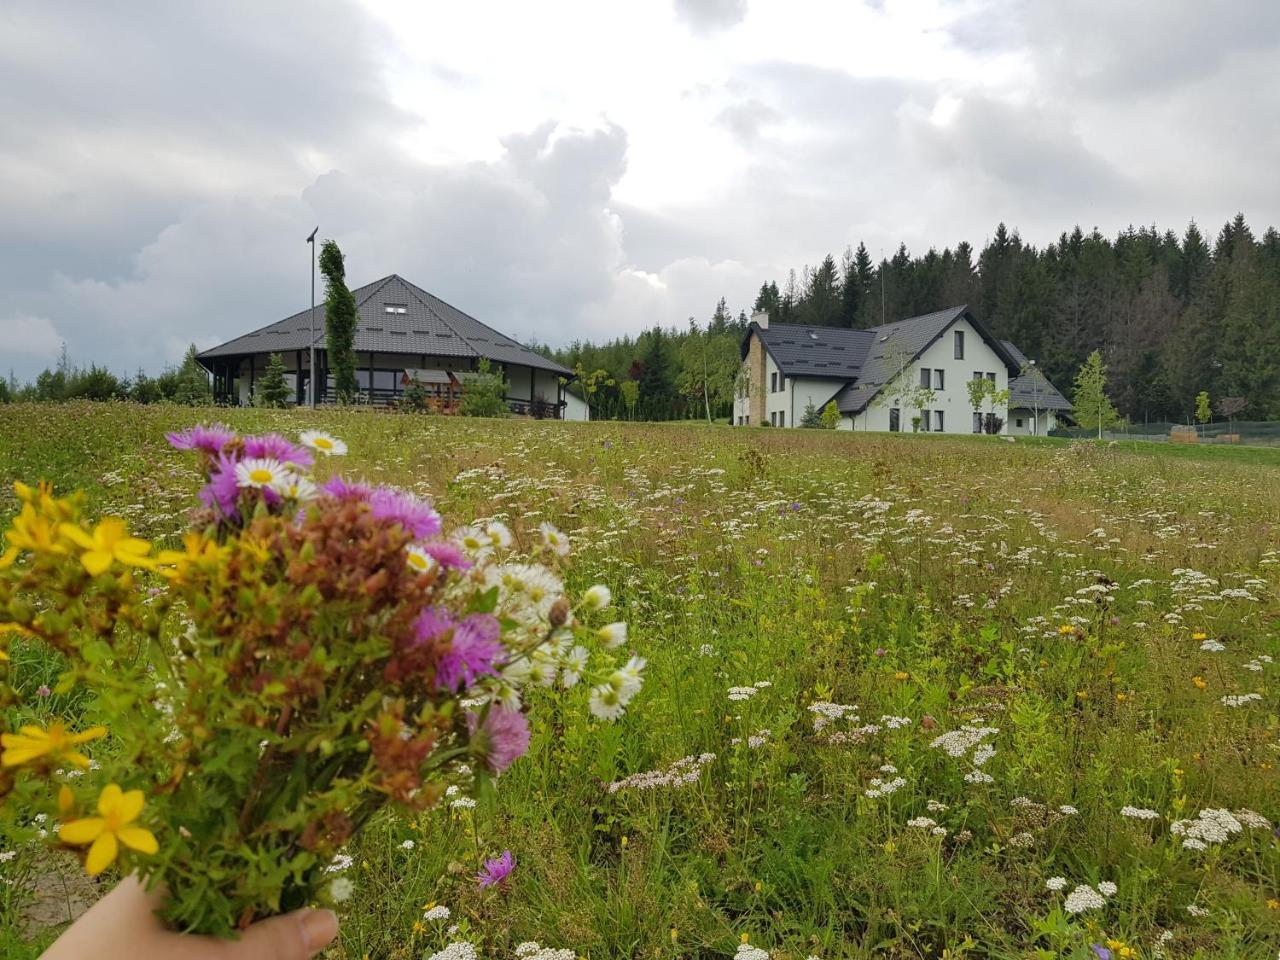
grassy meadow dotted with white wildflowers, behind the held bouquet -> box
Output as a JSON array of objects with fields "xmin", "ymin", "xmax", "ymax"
[{"xmin": 0, "ymin": 404, "xmax": 1280, "ymax": 960}]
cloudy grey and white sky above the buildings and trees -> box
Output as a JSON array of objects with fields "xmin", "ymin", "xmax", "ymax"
[{"xmin": 0, "ymin": 0, "xmax": 1280, "ymax": 378}]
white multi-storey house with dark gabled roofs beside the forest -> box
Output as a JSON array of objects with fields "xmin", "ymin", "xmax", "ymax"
[{"xmin": 733, "ymin": 306, "xmax": 1070, "ymax": 434}]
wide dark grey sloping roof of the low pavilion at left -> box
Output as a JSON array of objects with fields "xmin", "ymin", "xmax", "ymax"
[{"xmin": 197, "ymin": 274, "xmax": 572, "ymax": 376}]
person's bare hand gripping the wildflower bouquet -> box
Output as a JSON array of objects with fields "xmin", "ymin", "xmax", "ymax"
[{"xmin": 41, "ymin": 877, "xmax": 338, "ymax": 960}]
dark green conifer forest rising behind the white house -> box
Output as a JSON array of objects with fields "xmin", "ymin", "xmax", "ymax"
[{"xmin": 550, "ymin": 214, "xmax": 1280, "ymax": 422}]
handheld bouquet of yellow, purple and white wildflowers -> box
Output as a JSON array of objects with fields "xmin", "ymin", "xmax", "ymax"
[{"xmin": 0, "ymin": 426, "xmax": 644, "ymax": 934}]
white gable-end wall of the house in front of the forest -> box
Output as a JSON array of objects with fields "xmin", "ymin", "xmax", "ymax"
[{"xmin": 852, "ymin": 320, "xmax": 1009, "ymax": 434}]
